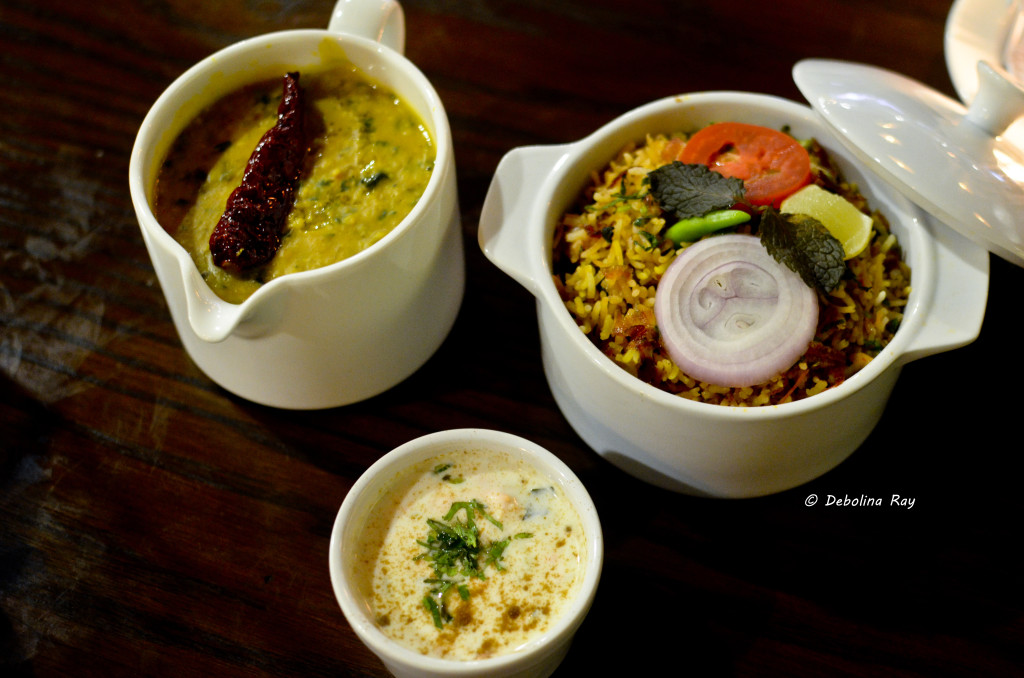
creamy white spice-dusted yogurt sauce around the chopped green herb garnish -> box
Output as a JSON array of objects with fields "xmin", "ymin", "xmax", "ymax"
[{"xmin": 356, "ymin": 450, "xmax": 586, "ymax": 660}]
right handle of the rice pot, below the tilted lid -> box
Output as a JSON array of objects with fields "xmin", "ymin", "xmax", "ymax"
[{"xmin": 902, "ymin": 217, "xmax": 989, "ymax": 363}]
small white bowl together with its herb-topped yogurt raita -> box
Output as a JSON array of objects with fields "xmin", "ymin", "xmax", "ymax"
[{"xmin": 330, "ymin": 429, "xmax": 603, "ymax": 677}]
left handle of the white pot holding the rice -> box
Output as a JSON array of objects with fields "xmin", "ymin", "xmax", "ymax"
[{"xmin": 477, "ymin": 145, "xmax": 569, "ymax": 296}]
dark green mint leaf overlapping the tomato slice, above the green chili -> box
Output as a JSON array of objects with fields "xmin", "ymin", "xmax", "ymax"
[{"xmin": 647, "ymin": 160, "xmax": 744, "ymax": 219}]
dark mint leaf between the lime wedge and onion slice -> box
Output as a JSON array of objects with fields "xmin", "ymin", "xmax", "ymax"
[{"xmin": 761, "ymin": 207, "xmax": 846, "ymax": 294}]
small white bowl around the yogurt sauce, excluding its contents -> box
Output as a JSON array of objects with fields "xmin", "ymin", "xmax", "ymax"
[{"xmin": 330, "ymin": 429, "xmax": 604, "ymax": 678}]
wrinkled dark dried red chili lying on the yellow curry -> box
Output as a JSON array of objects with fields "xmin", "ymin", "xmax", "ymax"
[{"xmin": 210, "ymin": 73, "xmax": 306, "ymax": 272}]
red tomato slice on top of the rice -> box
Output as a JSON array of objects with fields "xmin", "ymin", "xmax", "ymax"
[{"xmin": 678, "ymin": 123, "xmax": 811, "ymax": 207}]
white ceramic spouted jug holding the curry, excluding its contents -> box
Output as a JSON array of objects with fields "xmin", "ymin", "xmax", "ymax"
[{"xmin": 129, "ymin": 0, "xmax": 465, "ymax": 409}]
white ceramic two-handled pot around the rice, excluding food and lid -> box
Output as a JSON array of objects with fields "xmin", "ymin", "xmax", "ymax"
[{"xmin": 479, "ymin": 92, "xmax": 988, "ymax": 498}]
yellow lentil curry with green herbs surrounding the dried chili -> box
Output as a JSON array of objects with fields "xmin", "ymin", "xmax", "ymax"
[{"xmin": 154, "ymin": 63, "xmax": 436, "ymax": 303}]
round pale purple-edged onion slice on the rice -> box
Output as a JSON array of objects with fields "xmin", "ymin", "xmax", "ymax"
[{"xmin": 654, "ymin": 235, "xmax": 818, "ymax": 387}]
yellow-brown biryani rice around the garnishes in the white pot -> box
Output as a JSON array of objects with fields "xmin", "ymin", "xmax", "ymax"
[{"xmin": 553, "ymin": 134, "xmax": 910, "ymax": 407}]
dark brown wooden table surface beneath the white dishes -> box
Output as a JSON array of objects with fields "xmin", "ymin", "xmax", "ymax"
[{"xmin": 0, "ymin": 0, "xmax": 1024, "ymax": 677}]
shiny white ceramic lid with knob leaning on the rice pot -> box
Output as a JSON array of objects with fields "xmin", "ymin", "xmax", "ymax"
[{"xmin": 793, "ymin": 59, "xmax": 1024, "ymax": 266}]
